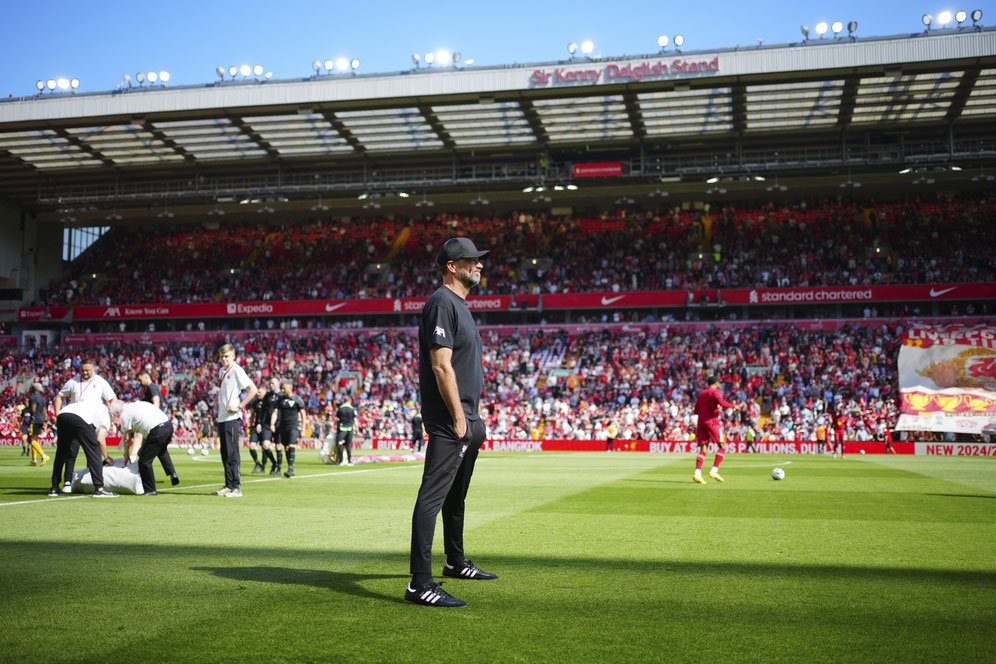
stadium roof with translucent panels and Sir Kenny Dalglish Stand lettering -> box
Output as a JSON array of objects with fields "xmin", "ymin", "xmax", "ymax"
[{"xmin": 0, "ymin": 28, "xmax": 996, "ymax": 223}]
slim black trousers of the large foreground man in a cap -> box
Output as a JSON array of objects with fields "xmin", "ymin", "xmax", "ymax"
[{"xmin": 410, "ymin": 420, "xmax": 486, "ymax": 575}]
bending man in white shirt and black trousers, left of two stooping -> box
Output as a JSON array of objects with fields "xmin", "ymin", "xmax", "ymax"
[{"xmin": 48, "ymin": 401, "xmax": 117, "ymax": 498}]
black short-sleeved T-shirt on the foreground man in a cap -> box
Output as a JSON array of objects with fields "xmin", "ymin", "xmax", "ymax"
[{"xmin": 418, "ymin": 286, "xmax": 484, "ymax": 425}]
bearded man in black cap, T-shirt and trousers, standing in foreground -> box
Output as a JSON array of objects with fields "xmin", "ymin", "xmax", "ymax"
[{"xmin": 405, "ymin": 237, "xmax": 498, "ymax": 608}]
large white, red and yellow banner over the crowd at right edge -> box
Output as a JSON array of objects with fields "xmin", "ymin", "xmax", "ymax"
[{"xmin": 896, "ymin": 324, "xmax": 996, "ymax": 435}]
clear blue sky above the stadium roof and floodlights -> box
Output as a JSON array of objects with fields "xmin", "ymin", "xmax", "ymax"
[{"xmin": 0, "ymin": 0, "xmax": 996, "ymax": 97}]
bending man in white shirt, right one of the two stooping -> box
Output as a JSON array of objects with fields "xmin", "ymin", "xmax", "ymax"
[{"xmin": 111, "ymin": 401, "xmax": 173, "ymax": 496}]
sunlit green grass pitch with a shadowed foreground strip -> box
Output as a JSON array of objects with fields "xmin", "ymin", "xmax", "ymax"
[{"xmin": 0, "ymin": 448, "xmax": 996, "ymax": 663}]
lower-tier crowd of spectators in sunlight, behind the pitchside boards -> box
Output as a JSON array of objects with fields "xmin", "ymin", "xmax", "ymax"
[{"xmin": 0, "ymin": 323, "xmax": 901, "ymax": 441}]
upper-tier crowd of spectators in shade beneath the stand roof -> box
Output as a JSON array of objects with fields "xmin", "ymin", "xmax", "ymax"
[{"xmin": 42, "ymin": 196, "xmax": 996, "ymax": 305}]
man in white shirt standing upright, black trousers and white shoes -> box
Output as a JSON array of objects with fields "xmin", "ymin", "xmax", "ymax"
[{"xmin": 214, "ymin": 344, "xmax": 256, "ymax": 498}]
